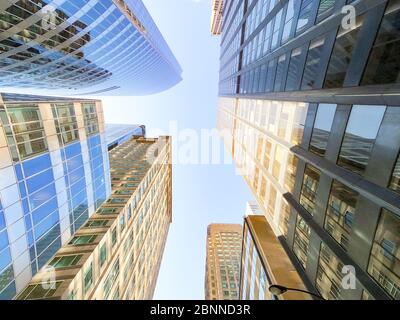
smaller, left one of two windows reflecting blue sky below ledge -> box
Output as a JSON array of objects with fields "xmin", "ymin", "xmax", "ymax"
[{"xmin": 310, "ymin": 104, "xmax": 336, "ymax": 157}]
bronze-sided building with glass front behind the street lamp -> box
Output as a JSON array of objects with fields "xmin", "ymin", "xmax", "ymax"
[{"xmin": 240, "ymin": 203, "xmax": 311, "ymax": 300}]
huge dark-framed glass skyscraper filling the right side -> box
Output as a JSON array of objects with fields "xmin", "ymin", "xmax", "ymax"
[{"xmin": 218, "ymin": 0, "xmax": 400, "ymax": 299}]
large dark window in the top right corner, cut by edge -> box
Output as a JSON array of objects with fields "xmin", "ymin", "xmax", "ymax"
[{"xmin": 362, "ymin": 0, "xmax": 400, "ymax": 85}]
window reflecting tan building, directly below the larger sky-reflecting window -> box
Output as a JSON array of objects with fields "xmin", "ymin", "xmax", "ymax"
[{"xmin": 325, "ymin": 180, "xmax": 359, "ymax": 250}]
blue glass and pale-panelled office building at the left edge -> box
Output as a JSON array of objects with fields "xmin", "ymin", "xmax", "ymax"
[{"xmin": 0, "ymin": 94, "xmax": 111, "ymax": 299}]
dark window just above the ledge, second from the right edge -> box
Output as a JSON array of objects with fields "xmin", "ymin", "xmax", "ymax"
[{"xmin": 324, "ymin": 17, "xmax": 363, "ymax": 88}]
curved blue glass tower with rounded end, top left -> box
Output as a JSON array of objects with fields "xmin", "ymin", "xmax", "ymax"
[{"xmin": 0, "ymin": 0, "xmax": 182, "ymax": 95}]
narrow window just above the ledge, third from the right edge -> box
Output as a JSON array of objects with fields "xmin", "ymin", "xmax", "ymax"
[{"xmin": 301, "ymin": 37, "xmax": 325, "ymax": 90}]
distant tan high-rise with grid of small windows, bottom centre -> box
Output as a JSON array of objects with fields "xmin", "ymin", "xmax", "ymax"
[{"xmin": 205, "ymin": 224, "xmax": 243, "ymax": 300}]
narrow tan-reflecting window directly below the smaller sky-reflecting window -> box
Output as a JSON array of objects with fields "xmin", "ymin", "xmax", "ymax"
[{"xmin": 300, "ymin": 164, "xmax": 321, "ymax": 215}]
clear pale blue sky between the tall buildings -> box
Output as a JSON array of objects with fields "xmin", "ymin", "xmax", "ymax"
[{"xmin": 103, "ymin": 0, "xmax": 252, "ymax": 299}]
